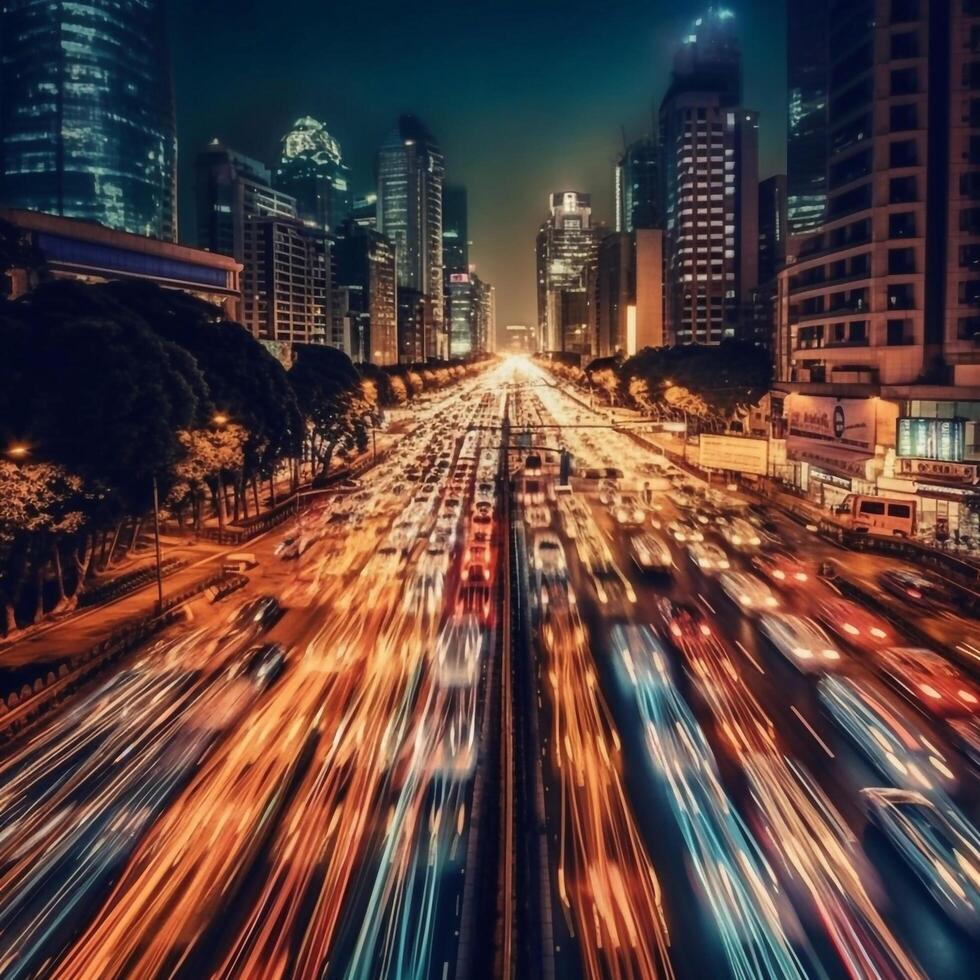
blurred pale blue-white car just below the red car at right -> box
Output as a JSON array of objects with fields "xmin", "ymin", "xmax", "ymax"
[{"xmin": 817, "ymin": 675, "xmax": 956, "ymax": 792}]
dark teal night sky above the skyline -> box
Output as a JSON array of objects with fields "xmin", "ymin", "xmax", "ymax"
[{"xmin": 170, "ymin": 0, "xmax": 788, "ymax": 331}]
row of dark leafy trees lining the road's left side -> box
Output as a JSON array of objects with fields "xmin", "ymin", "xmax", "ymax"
[{"xmin": 0, "ymin": 266, "xmax": 490, "ymax": 638}]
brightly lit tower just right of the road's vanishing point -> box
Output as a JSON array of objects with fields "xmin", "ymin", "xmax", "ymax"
[{"xmin": 536, "ymin": 191, "xmax": 599, "ymax": 351}]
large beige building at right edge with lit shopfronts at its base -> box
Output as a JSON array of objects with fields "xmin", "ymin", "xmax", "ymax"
[{"xmin": 773, "ymin": 0, "xmax": 980, "ymax": 533}]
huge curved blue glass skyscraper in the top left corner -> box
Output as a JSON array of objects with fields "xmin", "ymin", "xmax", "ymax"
[{"xmin": 0, "ymin": 0, "xmax": 177, "ymax": 241}]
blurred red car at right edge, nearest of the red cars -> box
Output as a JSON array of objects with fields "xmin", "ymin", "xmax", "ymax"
[{"xmin": 875, "ymin": 647, "xmax": 980, "ymax": 718}]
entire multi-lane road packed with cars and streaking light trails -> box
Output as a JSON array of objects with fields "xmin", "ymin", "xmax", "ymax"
[{"xmin": 0, "ymin": 358, "xmax": 980, "ymax": 980}]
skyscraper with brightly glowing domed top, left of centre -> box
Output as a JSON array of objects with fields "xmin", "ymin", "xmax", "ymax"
[{"xmin": 275, "ymin": 116, "xmax": 353, "ymax": 231}]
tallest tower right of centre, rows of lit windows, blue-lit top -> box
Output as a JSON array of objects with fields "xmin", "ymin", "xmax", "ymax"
[{"xmin": 660, "ymin": 8, "xmax": 758, "ymax": 344}]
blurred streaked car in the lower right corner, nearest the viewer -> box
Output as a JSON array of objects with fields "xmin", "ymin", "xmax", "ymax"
[{"xmin": 861, "ymin": 788, "xmax": 980, "ymax": 937}]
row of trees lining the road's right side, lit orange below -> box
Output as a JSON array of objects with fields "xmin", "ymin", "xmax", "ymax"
[{"xmin": 548, "ymin": 340, "xmax": 772, "ymax": 432}]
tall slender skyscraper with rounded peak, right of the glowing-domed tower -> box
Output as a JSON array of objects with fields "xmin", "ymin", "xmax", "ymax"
[{"xmin": 378, "ymin": 115, "xmax": 448, "ymax": 357}]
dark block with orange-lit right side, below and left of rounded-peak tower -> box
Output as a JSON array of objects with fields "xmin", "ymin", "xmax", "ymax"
[{"xmin": 333, "ymin": 220, "xmax": 398, "ymax": 364}]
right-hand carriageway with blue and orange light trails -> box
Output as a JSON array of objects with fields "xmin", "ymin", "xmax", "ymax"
[{"xmin": 510, "ymin": 368, "xmax": 978, "ymax": 977}]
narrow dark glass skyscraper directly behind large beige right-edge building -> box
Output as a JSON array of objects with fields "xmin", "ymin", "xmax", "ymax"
[{"xmin": 786, "ymin": 0, "xmax": 829, "ymax": 235}]
